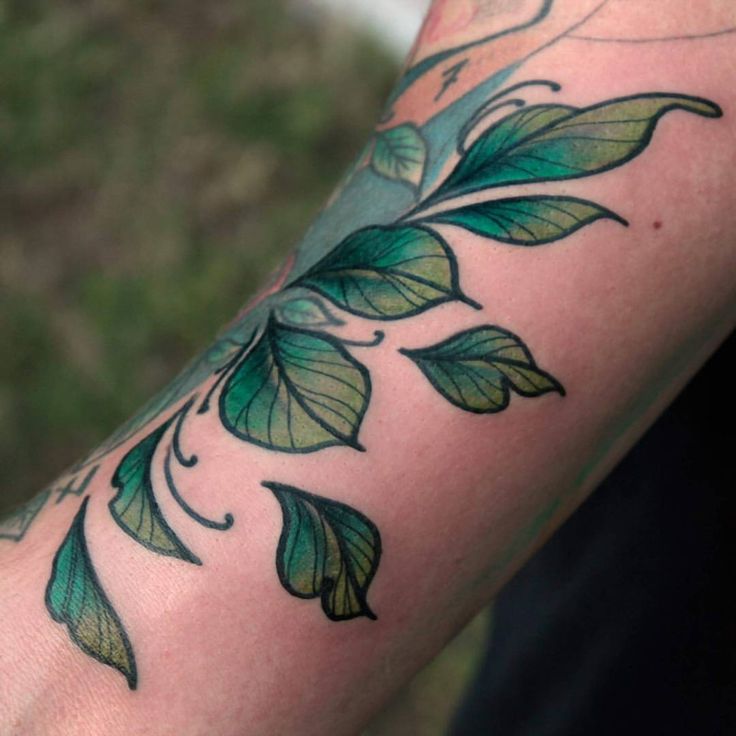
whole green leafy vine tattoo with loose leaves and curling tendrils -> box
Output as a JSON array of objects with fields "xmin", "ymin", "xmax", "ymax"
[{"xmin": 0, "ymin": 2, "xmax": 721, "ymax": 689}]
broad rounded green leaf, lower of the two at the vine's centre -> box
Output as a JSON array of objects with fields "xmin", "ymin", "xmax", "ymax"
[{"xmin": 220, "ymin": 317, "xmax": 371, "ymax": 452}]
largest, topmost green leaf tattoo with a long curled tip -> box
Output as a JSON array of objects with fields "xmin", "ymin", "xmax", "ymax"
[{"xmin": 430, "ymin": 93, "xmax": 722, "ymax": 201}]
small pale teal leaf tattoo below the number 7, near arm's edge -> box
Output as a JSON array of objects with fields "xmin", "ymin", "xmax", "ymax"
[{"xmin": 371, "ymin": 123, "xmax": 427, "ymax": 188}]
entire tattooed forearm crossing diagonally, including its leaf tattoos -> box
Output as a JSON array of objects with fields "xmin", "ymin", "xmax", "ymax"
[{"xmin": 0, "ymin": 0, "xmax": 736, "ymax": 736}]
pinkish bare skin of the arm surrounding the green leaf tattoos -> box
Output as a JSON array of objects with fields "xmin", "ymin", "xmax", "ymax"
[{"xmin": 0, "ymin": 0, "xmax": 736, "ymax": 736}]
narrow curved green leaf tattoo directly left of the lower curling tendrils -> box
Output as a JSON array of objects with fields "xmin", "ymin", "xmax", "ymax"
[{"xmin": 109, "ymin": 412, "xmax": 201, "ymax": 565}]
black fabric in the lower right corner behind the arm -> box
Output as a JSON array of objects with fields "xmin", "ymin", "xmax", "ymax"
[{"xmin": 450, "ymin": 336, "xmax": 736, "ymax": 736}]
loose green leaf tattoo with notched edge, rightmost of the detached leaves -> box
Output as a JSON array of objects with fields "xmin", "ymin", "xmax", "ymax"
[{"xmin": 400, "ymin": 325, "xmax": 565, "ymax": 414}]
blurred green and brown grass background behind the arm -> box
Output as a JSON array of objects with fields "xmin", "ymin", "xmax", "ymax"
[{"xmin": 0, "ymin": 0, "xmax": 486, "ymax": 736}]
